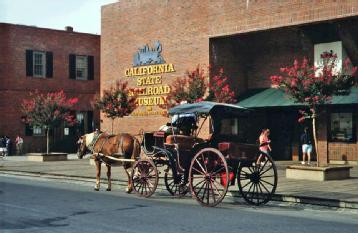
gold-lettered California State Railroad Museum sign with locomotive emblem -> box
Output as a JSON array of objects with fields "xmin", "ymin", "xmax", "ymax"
[{"xmin": 124, "ymin": 41, "xmax": 175, "ymax": 116}]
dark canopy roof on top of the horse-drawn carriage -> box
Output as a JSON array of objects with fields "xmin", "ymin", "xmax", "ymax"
[{"xmin": 169, "ymin": 101, "xmax": 251, "ymax": 118}]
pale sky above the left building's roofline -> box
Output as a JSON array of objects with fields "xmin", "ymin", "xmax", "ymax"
[{"xmin": 0, "ymin": 0, "xmax": 117, "ymax": 34}]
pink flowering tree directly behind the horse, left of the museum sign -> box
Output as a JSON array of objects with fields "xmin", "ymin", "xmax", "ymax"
[{"xmin": 94, "ymin": 81, "xmax": 137, "ymax": 133}]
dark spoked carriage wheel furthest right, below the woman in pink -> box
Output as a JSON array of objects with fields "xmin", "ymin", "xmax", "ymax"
[{"xmin": 237, "ymin": 154, "xmax": 277, "ymax": 205}]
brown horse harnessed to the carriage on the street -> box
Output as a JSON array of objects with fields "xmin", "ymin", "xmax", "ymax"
[{"xmin": 77, "ymin": 132, "xmax": 140, "ymax": 193}]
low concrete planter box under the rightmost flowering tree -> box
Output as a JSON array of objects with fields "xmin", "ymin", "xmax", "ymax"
[{"xmin": 286, "ymin": 165, "xmax": 352, "ymax": 181}]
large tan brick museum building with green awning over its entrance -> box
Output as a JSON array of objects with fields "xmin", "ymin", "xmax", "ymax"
[{"xmin": 101, "ymin": 0, "xmax": 358, "ymax": 162}]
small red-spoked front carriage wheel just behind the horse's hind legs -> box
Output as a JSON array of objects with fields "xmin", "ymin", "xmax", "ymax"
[{"xmin": 131, "ymin": 159, "xmax": 158, "ymax": 197}]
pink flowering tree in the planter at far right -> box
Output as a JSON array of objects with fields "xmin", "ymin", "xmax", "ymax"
[{"xmin": 271, "ymin": 51, "xmax": 357, "ymax": 166}]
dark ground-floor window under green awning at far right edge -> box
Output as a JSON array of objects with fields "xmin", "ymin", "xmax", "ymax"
[{"xmin": 330, "ymin": 112, "xmax": 355, "ymax": 142}]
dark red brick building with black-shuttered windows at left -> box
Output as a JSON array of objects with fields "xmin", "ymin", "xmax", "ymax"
[{"xmin": 0, "ymin": 23, "xmax": 100, "ymax": 153}]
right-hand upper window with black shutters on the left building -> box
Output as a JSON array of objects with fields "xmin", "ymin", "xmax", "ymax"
[{"xmin": 69, "ymin": 54, "xmax": 94, "ymax": 80}]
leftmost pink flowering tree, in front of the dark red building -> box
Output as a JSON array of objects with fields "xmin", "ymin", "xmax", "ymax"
[{"xmin": 21, "ymin": 91, "xmax": 78, "ymax": 154}]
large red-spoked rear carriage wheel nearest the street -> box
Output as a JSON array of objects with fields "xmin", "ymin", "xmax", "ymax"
[{"xmin": 189, "ymin": 148, "xmax": 229, "ymax": 207}]
